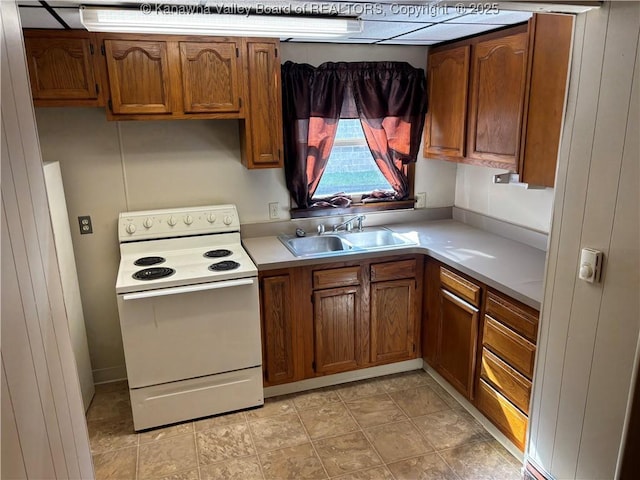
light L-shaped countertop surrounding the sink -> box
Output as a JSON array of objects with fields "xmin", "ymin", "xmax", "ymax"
[{"xmin": 242, "ymin": 220, "xmax": 546, "ymax": 310}]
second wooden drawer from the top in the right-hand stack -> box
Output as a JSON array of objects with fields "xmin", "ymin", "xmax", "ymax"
[{"xmin": 482, "ymin": 315, "xmax": 536, "ymax": 378}]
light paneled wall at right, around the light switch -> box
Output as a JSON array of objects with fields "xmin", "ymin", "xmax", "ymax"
[{"xmin": 528, "ymin": 2, "xmax": 640, "ymax": 479}]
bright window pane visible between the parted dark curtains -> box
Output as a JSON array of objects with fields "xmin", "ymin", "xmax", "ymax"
[{"xmin": 314, "ymin": 118, "xmax": 393, "ymax": 199}]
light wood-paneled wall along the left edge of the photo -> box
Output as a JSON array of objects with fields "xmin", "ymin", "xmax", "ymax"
[{"xmin": 0, "ymin": 1, "xmax": 94, "ymax": 479}]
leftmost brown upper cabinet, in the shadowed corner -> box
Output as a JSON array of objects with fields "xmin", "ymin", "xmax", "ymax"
[{"xmin": 24, "ymin": 30, "xmax": 104, "ymax": 107}]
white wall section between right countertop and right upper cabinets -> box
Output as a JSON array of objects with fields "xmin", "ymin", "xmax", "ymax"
[{"xmin": 455, "ymin": 164, "xmax": 553, "ymax": 233}]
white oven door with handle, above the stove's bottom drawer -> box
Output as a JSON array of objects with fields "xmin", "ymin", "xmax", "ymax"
[{"xmin": 118, "ymin": 277, "xmax": 262, "ymax": 388}]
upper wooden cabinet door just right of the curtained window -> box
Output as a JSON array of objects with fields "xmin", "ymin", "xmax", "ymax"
[{"xmin": 424, "ymin": 45, "xmax": 471, "ymax": 158}]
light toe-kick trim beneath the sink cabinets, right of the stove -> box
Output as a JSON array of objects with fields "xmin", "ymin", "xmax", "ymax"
[{"xmin": 264, "ymin": 358, "xmax": 423, "ymax": 398}]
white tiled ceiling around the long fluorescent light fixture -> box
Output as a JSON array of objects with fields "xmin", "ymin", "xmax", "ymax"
[{"xmin": 18, "ymin": 0, "xmax": 599, "ymax": 45}]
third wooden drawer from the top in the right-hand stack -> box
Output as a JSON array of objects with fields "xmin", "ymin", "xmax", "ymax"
[{"xmin": 480, "ymin": 348, "xmax": 531, "ymax": 414}]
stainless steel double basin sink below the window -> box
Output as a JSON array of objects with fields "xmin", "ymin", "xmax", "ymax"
[{"xmin": 278, "ymin": 227, "xmax": 416, "ymax": 257}]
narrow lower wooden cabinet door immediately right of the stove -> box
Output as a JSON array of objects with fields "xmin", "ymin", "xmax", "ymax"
[{"xmin": 262, "ymin": 275, "xmax": 294, "ymax": 384}]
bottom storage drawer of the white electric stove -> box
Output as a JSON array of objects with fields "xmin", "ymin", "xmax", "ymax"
[{"xmin": 130, "ymin": 367, "xmax": 264, "ymax": 430}]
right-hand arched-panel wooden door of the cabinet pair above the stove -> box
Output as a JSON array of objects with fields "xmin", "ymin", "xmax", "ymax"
[{"xmin": 180, "ymin": 42, "xmax": 240, "ymax": 113}]
